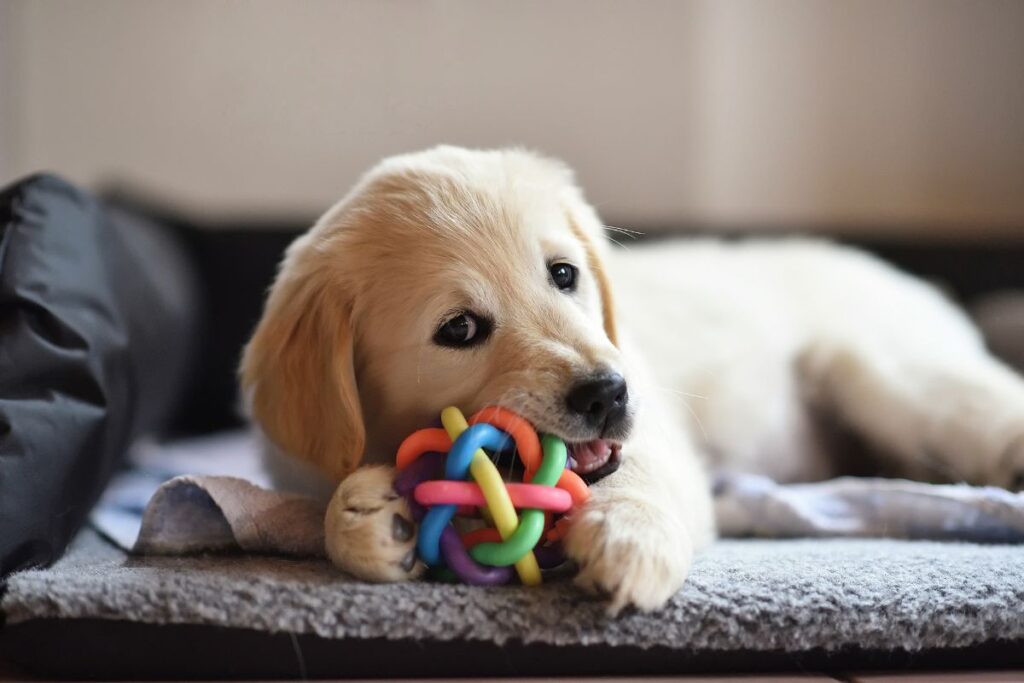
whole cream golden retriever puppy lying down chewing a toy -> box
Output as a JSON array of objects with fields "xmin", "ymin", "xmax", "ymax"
[{"xmin": 242, "ymin": 146, "xmax": 1024, "ymax": 611}]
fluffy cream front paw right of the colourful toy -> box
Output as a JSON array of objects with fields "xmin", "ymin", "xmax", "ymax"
[{"xmin": 565, "ymin": 489, "xmax": 693, "ymax": 614}]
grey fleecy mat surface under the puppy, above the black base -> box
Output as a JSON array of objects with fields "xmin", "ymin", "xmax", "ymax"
[{"xmin": 0, "ymin": 530, "xmax": 1024, "ymax": 651}]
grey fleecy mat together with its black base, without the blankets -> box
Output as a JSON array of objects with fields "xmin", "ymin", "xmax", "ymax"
[{"xmin": 0, "ymin": 529, "xmax": 1024, "ymax": 678}]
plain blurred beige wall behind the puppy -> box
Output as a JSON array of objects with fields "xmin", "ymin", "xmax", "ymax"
[{"xmin": 0, "ymin": 0, "xmax": 1024, "ymax": 235}]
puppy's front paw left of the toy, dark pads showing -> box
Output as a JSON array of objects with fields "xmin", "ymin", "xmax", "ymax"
[{"xmin": 324, "ymin": 467, "xmax": 424, "ymax": 582}]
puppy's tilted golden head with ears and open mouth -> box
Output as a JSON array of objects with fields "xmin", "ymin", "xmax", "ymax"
[{"xmin": 242, "ymin": 147, "xmax": 632, "ymax": 478}]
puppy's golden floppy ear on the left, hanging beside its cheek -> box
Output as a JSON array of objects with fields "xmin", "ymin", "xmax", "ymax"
[{"xmin": 241, "ymin": 239, "xmax": 366, "ymax": 480}]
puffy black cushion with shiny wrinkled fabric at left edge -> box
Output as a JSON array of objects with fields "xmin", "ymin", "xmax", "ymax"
[{"xmin": 0, "ymin": 175, "xmax": 198, "ymax": 577}]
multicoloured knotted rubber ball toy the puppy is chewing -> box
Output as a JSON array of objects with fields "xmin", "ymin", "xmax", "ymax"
[{"xmin": 394, "ymin": 407, "xmax": 590, "ymax": 586}]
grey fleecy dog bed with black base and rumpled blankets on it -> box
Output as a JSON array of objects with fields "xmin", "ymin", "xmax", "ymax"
[{"xmin": 8, "ymin": 432, "xmax": 1024, "ymax": 678}]
